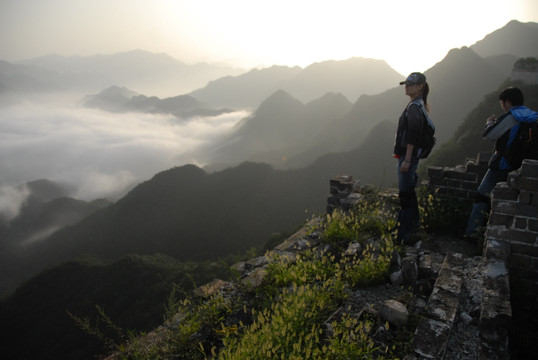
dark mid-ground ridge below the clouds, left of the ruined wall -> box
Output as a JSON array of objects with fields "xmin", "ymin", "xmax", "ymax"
[{"xmin": 16, "ymin": 163, "xmax": 320, "ymax": 282}]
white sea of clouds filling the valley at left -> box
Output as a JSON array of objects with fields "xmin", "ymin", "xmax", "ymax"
[{"xmin": 0, "ymin": 95, "xmax": 248, "ymax": 218}]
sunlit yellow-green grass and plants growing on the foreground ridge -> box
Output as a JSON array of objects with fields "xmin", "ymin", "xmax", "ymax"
[{"xmin": 103, "ymin": 201, "xmax": 409, "ymax": 360}]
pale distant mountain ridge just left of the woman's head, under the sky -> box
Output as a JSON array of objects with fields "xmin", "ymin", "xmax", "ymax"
[{"xmin": 191, "ymin": 58, "xmax": 402, "ymax": 109}]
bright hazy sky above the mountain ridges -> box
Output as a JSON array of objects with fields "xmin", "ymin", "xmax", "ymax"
[{"xmin": 0, "ymin": 0, "xmax": 538, "ymax": 74}]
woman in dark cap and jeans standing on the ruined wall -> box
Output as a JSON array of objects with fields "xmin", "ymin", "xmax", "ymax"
[{"xmin": 394, "ymin": 72, "xmax": 430, "ymax": 244}]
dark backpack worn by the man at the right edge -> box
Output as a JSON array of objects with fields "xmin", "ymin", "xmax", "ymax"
[{"xmin": 503, "ymin": 121, "xmax": 538, "ymax": 170}]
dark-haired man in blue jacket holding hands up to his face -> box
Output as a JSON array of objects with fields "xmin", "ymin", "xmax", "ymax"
[{"xmin": 465, "ymin": 87, "xmax": 538, "ymax": 238}]
